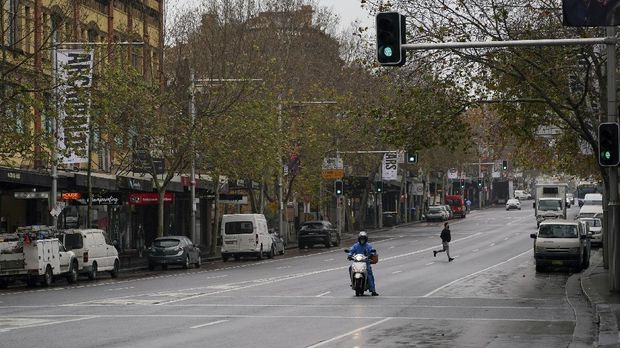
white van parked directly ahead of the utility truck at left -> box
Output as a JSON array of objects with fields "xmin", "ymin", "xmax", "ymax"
[{"xmin": 59, "ymin": 229, "xmax": 120, "ymax": 280}]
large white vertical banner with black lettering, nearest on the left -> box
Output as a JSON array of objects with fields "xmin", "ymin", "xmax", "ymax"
[{"xmin": 56, "ymin": 49, "xmax": 94, "ymax": 164}]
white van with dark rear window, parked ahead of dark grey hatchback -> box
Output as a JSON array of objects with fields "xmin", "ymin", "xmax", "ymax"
[{"xmin": 221, "ymin": 214, "xmax": 275, "ymax": 262}]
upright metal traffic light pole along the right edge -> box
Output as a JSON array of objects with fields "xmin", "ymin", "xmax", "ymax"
[{"xmin": 603, "ymin": 27, "xmax": 620, "ymax": 291}]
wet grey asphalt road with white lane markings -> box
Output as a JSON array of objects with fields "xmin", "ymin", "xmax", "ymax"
[{"xmin": 0, "ymin": 201, "xmax": 592, "ymax": 347}]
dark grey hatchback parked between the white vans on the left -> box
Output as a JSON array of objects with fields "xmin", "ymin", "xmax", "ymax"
[{"xmin": 148, "ymin": 236, "xmax": 202, "ymax": 270}]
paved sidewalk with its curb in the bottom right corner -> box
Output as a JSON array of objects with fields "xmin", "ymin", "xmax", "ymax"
[{"xmin": 581, "ymin": 249, "xmax": 620, "ymax": 347}]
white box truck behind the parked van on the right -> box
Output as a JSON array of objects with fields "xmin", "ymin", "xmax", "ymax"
[{"xmin": 533, "ymin": 183, "xmax": 568, "ymax": 227}]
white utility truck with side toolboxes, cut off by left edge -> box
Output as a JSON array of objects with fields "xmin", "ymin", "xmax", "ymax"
[{"xmin": 0, "ymin": 232, "xmax": 78, "ymax": 287}]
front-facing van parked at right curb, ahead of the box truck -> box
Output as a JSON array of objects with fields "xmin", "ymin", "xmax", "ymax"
[{"xmin": 530, "ymin": 220, "xmax": 591, "ymax": 271}]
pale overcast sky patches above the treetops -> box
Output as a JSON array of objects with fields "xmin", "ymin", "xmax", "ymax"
[{"xmin": 166, "ymin": 0, "xmax": 373, "ymax": 29}]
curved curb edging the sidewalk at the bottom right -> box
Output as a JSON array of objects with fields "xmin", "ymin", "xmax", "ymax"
[{"xmin": 579, "ymin": 254, "xmax": 620, "ymax": 347}]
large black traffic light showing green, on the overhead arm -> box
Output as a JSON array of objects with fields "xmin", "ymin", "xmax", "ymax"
[{"xmin": 376, "ymin": 12, "xmax": 407, "ymax": 66}]
